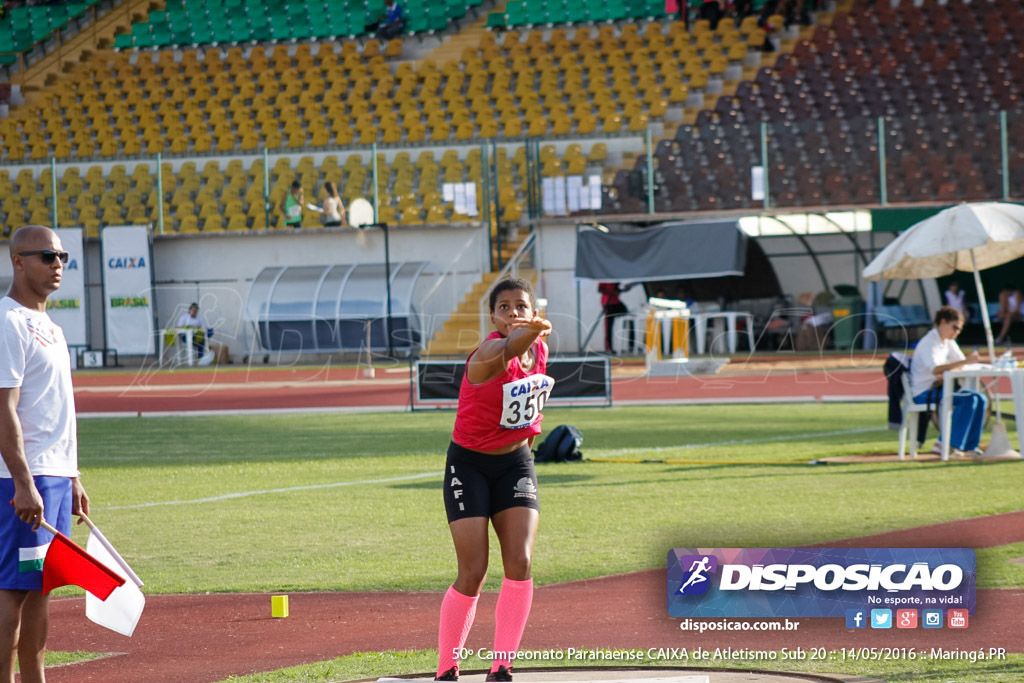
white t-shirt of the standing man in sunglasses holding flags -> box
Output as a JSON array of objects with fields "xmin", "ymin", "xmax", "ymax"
[{"xmin": 0, "ymin": 297, "xmax": 78, "ymax": 479}]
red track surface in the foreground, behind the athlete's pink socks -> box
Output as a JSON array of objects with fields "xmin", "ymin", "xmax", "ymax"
[{"xmin": 47, "ymin": 512, "xmax": 1024, "ymax": 683}]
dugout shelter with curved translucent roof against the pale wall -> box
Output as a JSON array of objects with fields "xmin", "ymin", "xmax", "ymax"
[{"xmin": 244, "ymin": 261, "xmax": 427, "ymax": 353}]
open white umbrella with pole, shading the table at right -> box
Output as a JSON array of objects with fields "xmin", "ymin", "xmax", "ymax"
[{"xmin": 863, "ymin": 202, "xmax": 1024, "ymax": 458}]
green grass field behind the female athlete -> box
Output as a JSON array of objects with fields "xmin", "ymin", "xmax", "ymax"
[{"xmin": 56, "ymin": 403, "xmax": 1024, "ymax": 682}]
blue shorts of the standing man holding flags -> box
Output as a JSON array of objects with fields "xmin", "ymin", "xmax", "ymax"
[{"xmin": 0, "ymin": 476, "xmax": 72, "ymax": 591}]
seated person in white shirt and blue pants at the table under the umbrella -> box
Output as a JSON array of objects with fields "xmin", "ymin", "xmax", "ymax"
[{"xmin": 910, "ymin": 306, "xmax": 988, "ymax": 456}]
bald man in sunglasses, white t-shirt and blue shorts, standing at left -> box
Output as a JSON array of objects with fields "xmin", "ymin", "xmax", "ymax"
[{"xmin": 0, "ymin": 225, "xmax": 89, "ymax": 683}]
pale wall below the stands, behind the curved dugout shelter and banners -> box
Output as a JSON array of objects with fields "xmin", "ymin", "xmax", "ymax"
[{"xmin": 0, "ymin": 222, "xmax": 897, "ymax": 359}]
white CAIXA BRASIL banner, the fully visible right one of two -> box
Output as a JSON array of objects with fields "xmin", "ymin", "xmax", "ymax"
[{"xmin": 99, "ymin": 225, "xmax": 156, "ymax": 355}]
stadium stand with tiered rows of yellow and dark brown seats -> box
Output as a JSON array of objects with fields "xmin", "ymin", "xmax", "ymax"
[{"xmin": 0, "ymin": 0, "xmax": 1024, "ymax": 234}]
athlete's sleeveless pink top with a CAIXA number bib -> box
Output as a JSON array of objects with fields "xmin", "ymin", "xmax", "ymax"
[{"xmin": 452, "ymin": 332, "xmax": 555, "ymax": 451}]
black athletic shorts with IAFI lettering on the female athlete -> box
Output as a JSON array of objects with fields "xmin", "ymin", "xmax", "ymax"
[{"xmin": 444, "ymin": 441, "xmax": 541, "ymax": 523}]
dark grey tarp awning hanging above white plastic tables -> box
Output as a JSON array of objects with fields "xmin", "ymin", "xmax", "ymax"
[{"xmin": 575, "ymin": 220, "xmax": 746, "ymax": 284}]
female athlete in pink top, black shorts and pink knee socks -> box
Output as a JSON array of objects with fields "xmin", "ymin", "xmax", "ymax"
[{"xmin": 434, "ymin": 280, "xmax": 554, "ymax": 681}]
